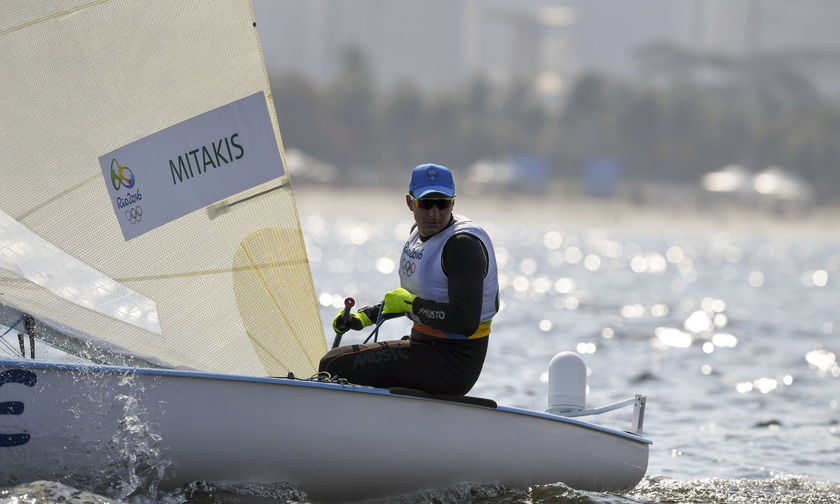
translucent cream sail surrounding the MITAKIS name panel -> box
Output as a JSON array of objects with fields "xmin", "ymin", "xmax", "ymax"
[{"xmin": 0, "ymin": 0, "xmax": 326, "ymax": 376}]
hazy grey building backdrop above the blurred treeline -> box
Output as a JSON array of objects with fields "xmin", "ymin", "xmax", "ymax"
[{"xmin": 253, "ymin": 0, "xmax": 840, "ymax": 96}]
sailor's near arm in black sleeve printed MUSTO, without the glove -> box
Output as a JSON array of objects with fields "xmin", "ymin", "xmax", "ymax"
[{"xmin": 414, "ymin": 234, "xmax": 487, "ymax": 336}]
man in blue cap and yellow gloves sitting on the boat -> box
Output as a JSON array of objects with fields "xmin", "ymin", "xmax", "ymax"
[{"xmin": 319, "ymin": 163, "xmax": 499, "ymax": 395}]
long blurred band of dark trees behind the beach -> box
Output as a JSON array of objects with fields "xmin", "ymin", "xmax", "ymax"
[{"xmin": 271, "ymin": 45, "xmax": 840, "ymax": 201}]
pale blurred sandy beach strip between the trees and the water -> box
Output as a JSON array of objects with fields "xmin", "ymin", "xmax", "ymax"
[{"xmin": 293, "ymin": 182, "xmax": 840, "ymax": 238}]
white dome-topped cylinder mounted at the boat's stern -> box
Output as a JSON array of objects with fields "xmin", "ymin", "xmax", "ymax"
[{"xmin": 546, "ymin": 352, "xmax": 586, "ymax": 414}]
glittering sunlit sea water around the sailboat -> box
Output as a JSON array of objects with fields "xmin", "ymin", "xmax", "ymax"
[{"xmin": 0, "ymin": 188, "xmax": 840, "ymax": 504}]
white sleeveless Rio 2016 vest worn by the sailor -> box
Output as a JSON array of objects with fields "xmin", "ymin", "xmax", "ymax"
[{"xmin": 399, "ymin": 215, "xmax": 499, "ymax": 339}]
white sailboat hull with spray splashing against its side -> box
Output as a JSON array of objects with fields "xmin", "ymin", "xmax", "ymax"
[{"xmin": 0, "ymin": 361, "xmax": 650, "ymax": 501}]
